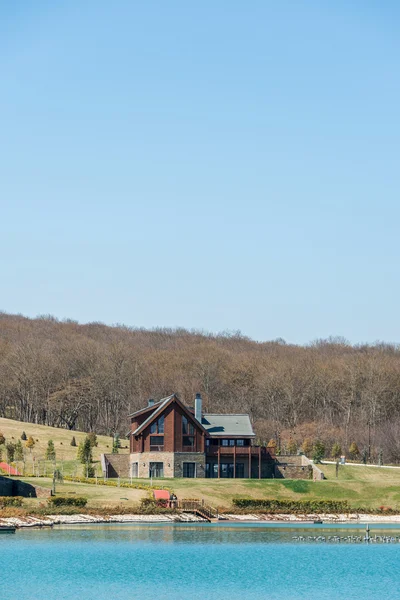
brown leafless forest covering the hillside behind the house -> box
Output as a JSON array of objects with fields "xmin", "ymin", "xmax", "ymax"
[{"xmin": 0, "ymin": 313, "xmax": 400, "ymax": 462}]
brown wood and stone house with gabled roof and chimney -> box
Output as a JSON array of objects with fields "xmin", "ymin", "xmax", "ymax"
[{"xmin": 129, "ymin": 394, "xmax": 275, "ymax": 479}]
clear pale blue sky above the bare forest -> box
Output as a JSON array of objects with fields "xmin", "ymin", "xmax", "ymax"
[{"xmin": 0, "ymin": 0, "xmax": 400, "ymax": 343}]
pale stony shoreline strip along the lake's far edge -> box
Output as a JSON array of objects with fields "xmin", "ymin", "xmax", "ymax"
[{"xmin": 0, "ymin": 513, "xmax": 400, "ymax": 529}]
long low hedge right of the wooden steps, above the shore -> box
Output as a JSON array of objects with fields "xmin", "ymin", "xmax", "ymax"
[{"xmin": 233, "ymin": 498, "xmax": 351, "ymax": 513}]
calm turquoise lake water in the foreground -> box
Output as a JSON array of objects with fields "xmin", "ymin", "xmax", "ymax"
[{"xmin": 0, "ymin": 524, "xmax": 400, "ymax": 600}]
